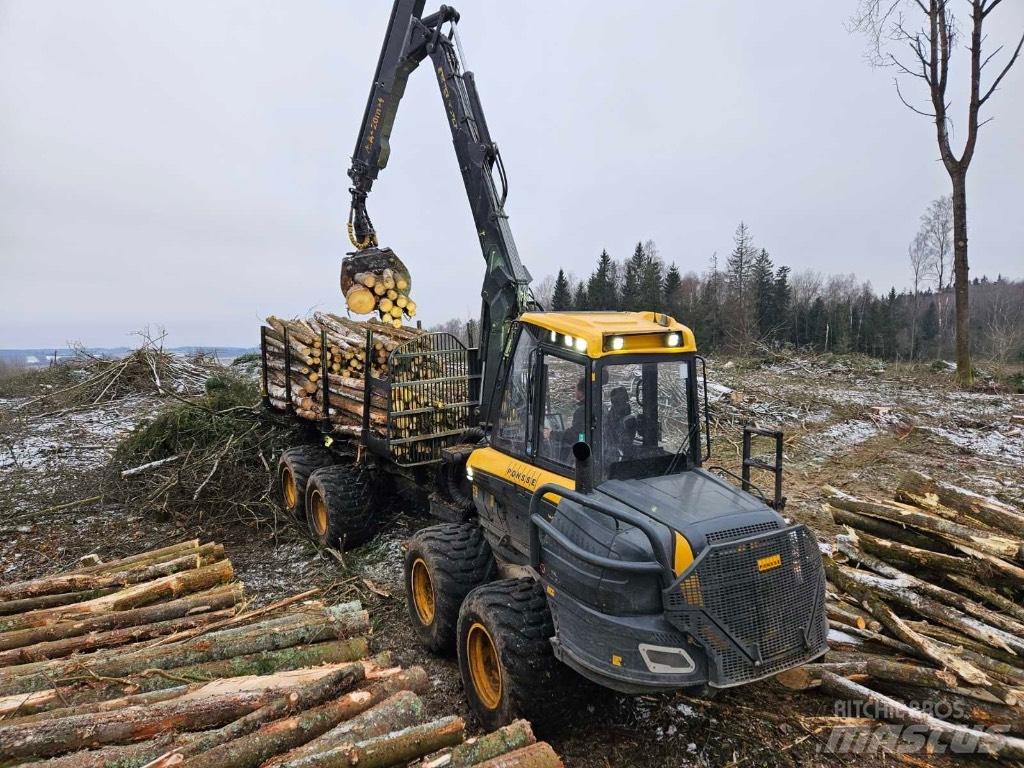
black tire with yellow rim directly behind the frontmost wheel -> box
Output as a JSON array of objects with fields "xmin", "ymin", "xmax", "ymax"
[{"xmin": 404, "ymin": 522, "xmax": 498, "ymax": 653}]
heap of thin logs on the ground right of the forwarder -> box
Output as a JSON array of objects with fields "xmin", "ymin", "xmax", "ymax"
[{"xmin": 778, "ymin": 472, "xmax": 1024, "ymax": 760}]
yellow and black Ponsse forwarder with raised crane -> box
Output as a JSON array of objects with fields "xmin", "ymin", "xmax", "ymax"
[{"xmin": 282, "ymin": 0, "xmax": 826, "ymax": 728}]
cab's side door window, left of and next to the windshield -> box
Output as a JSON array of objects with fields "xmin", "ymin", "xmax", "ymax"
[{"xmin": 539, "ymin": 354, "xmax": 587, "ymax": 466}]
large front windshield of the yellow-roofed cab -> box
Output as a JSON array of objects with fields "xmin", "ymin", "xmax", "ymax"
[{"xmin": 600, "ymin": 357, "xmax": 698, "ymax": 477}]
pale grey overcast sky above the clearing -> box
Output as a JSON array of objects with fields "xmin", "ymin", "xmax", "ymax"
[{"xmin": 0, "ymin": 0, "xmax": 1024, "ymax": 347}]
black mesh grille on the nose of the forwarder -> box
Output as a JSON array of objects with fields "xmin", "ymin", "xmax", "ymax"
[{"xmin": 667, "ymin": 525, "xmax": 827, "ymax": 686}]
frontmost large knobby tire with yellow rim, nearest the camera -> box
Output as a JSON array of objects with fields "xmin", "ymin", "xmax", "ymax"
[{"xmin": 458, "ymin": 579, "xmax": 586, "ymax": 732}]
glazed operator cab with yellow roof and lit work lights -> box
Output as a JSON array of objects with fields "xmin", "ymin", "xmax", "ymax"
[{"xmin": 492, "ymin": 312, "xmax": 701, "ymax": 481}]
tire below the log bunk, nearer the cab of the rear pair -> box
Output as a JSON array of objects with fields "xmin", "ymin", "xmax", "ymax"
[{"xmin": 305, "ymin": 464, "xmax": 379, "ymax": 550}]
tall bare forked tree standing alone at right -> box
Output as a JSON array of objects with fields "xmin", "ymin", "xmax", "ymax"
[{"xmin": 852, "ymin": 0, "xmax": 1024, "ymax": 386}]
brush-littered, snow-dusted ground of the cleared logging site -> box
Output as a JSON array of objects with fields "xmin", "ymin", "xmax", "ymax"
[{"xmin": 0, "ymin": 346, "xmax": 1024, "ymax": 768}]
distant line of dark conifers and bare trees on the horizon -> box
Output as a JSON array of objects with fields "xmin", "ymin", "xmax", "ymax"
[{"xmin": 438, "ymin": 223, "xmax": 1024, "ymax": 362}]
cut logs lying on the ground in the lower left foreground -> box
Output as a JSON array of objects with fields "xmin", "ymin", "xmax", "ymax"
[{"xmin": 0, "ymin": 541, "xmax": 562, "ymax": 768}]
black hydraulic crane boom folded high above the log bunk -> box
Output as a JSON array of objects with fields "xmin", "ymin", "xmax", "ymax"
[{"xmin": 348, "ymin": 0, "xmax": 538, "ymax": 424}]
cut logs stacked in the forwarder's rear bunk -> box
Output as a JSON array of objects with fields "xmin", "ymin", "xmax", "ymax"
[{"xmin": 263, "ymin": 312, "xmax": 472, "ymax": 461}]
